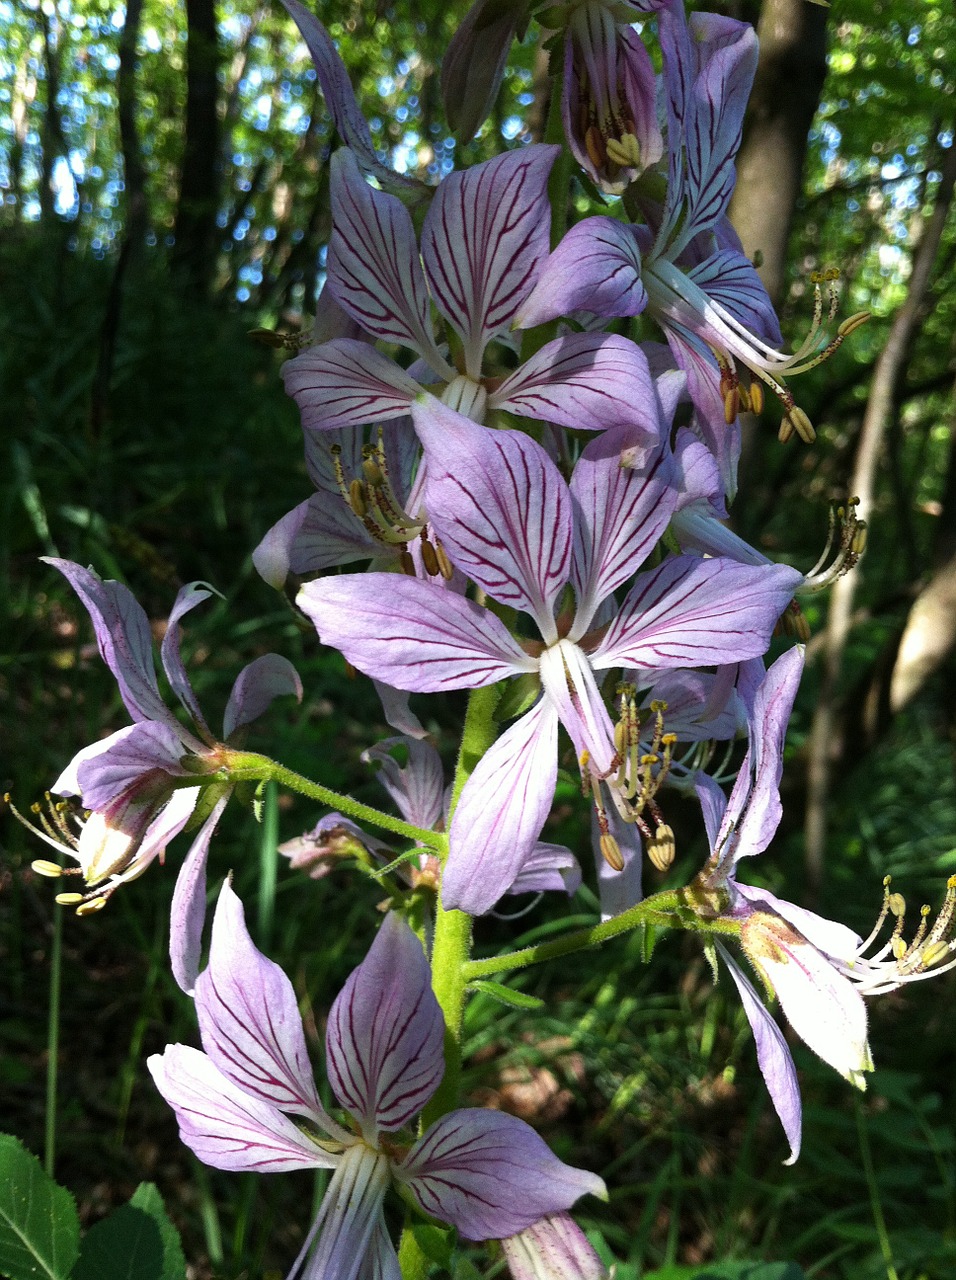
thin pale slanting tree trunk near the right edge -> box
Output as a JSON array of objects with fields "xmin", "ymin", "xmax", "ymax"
[{"xmin": 805, "ymin": 135, "xmax": 956, "ymax": 899}]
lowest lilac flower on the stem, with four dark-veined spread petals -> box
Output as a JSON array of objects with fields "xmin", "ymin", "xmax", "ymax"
[{"xmin": 148, "ymin": 884, "xmax": 604, "ymax": 1280}]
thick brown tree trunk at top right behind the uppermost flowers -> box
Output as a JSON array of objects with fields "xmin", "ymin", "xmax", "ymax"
[{"xmin": 729, "ymin": 0, "xmax": 827, "ymax": 305}]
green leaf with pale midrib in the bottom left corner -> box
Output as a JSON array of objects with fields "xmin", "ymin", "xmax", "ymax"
[{"xmin": 0, "ymin": 1133, "xmax": 79, "ymax": 1280}]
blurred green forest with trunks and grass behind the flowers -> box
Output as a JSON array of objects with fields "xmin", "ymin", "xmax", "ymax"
[{"xmin": 0, "ymin": 0, "xmax": 956, "ymax": 1280}]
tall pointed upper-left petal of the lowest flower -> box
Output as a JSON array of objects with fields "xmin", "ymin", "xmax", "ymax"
[{"xmin": 196, "ymin": 881, "xmax": 344, "ymax": 1139}]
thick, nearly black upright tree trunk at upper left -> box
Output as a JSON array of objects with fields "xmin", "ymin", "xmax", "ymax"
[{"xmin": 173, "ymin": 0, "xmax": 219, "ymax": 297}]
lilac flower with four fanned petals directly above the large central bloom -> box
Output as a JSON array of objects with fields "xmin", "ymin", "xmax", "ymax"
[{"xmin": 283, "ymin": 146, "xmax": 658, "ymax": 443}]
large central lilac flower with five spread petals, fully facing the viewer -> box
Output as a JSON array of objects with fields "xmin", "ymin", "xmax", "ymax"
[{"xmin": 298, "ymin": 398, "xmax": 799, "ymax": 915}]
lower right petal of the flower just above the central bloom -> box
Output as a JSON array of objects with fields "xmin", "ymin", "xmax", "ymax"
[{"xmin": 489, "ymin": 333, "xmax": 660, "ymax": 443}]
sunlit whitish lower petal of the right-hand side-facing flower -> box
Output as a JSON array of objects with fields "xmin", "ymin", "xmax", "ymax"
[{"xmin": 740, "ymin": 911, "xmax": 873, "ymax": 1089}]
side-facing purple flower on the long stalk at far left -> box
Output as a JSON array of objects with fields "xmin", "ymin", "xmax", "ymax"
[{"xmin": 28, "ymin": 559, "xmax": 302, "ymax": 991}]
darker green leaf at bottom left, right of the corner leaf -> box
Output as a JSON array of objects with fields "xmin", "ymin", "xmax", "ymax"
[{"xmin": 70, "ymin": 1183, "xmax": 186, "ymax": 1280}]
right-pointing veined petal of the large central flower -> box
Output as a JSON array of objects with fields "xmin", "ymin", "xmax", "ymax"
[{"xmin": 591, "ymin": 556, "xmax": 802, "ymax": 671}]
